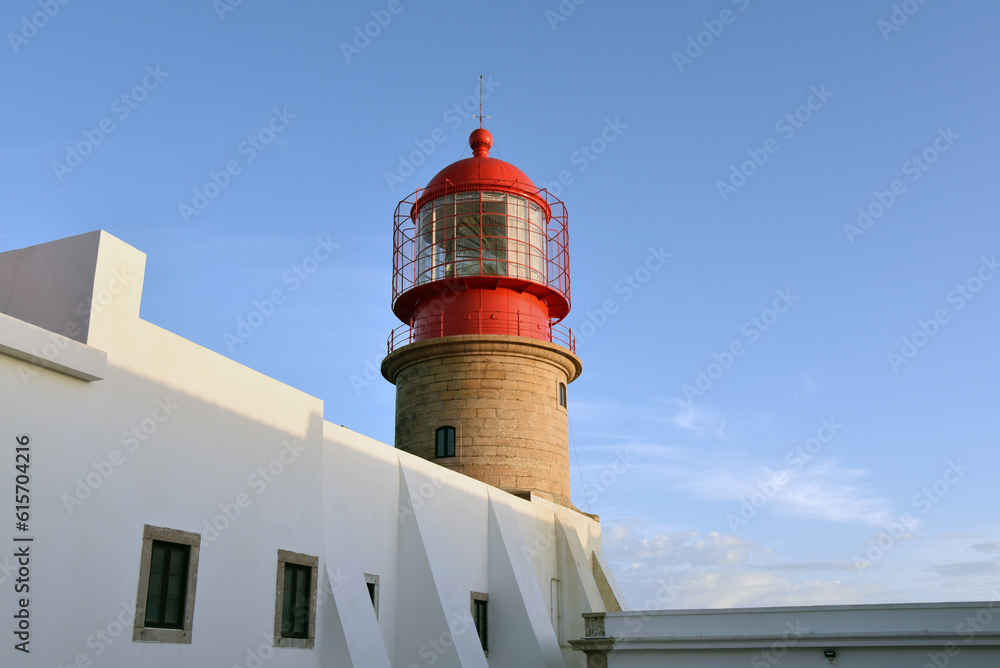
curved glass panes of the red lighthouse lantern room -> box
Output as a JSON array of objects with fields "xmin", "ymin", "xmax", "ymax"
[{"xmin": 415, "ymin": 191, "xmax": 546, "ymax": 284}]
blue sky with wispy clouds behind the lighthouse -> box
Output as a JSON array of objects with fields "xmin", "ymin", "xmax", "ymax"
[{"xmin": 0, "ymin": 0, "xmax": 1000, "ymax": 608}]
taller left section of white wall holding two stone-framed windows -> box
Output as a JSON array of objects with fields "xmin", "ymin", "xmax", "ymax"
[{"xmin": 0, "ymin": 233, "xmax": 323, "ymax": 666}]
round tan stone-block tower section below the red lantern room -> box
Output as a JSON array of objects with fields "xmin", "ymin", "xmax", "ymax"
[{"xmin": 382, "ymin": 335, "xmax": 582, "ymax": 507}]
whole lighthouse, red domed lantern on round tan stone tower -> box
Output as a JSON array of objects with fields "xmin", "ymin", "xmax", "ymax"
[{"xmin": 382, "ymin": 127, "xmax": 582, "ymax": 507}]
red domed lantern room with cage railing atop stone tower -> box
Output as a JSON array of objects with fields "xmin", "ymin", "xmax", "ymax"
[{"xmin": 389, "ymin": 128, "xmax": 574, "ymax": 352}]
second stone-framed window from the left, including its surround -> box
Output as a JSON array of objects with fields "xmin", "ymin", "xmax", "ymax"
[{"xmin": 274, "ymin": 550, "xmax": 319, "ymax": 649}]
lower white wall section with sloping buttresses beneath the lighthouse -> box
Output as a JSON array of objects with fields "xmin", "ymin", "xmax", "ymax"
[{"xmin": 324, "ymin": 423, "xmax": 606, "ymax": 668}]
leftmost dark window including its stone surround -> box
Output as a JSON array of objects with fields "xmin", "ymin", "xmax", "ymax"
[{"xmin": 132, "ymin": 524, "xmax": 201, "ymax": 644}]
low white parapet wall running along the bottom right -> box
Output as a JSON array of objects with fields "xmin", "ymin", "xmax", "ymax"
[{"xmin": 573, "ymin": 592, "xmax": 1000, "ymax": 668}]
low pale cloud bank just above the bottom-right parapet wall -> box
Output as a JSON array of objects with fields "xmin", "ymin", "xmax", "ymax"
[{"xmin": 603, "ymin": 519, "xmax": 1000, "ymax": 610}]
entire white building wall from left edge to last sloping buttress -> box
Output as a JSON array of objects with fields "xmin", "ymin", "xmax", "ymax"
[{"xmin": 0, "ymin": 232, "xmax": 603, "ymax": 668}]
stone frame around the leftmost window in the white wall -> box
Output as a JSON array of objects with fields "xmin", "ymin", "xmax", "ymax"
[{"xmin": 132, "ymin": 524, "xmax": 201, "ymax": 645}]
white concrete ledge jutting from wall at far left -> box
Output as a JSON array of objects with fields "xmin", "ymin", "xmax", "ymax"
[{"xmin": 0, "ymin": 313, "xmax": 108, "ymax": 382}]
